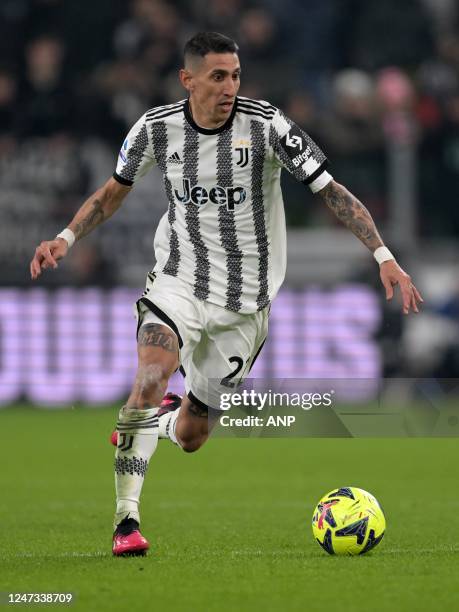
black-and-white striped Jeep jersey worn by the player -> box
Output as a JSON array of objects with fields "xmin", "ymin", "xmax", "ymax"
[{"xmin": 114, "ymin": 97, "xmax": 332, "ymax": 313}]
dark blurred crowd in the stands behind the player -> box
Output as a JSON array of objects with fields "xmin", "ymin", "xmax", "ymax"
[{"xmin": 0, "ymin": 0, "xmax": 459, "ymax": 284}]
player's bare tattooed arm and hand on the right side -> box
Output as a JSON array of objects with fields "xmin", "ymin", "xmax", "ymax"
[{"xmin": 318, "ymin": 180, "xmax": 423, "ymax": 314}]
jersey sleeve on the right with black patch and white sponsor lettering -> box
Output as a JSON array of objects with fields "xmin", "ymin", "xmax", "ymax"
[{"xmin": 269, "ymin": 110, "xmax": 332, "ymax": 191}]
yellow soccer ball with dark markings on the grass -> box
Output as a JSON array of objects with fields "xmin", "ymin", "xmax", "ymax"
[{"xmin": 312, "ymin": 487, "xmax": 386, "ymax": 555}]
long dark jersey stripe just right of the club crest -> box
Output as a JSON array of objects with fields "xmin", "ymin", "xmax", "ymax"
[{"xmin": 250, "ymin": 119, "xmax": 269, "ymax": 310}]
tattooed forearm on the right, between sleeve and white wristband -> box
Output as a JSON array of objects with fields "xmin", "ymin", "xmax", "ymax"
[{"xmin": 320, "ymin": 181, "xmax": 384, "ymax": 251}]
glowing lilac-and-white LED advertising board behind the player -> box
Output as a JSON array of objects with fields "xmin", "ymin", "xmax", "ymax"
[{"xmin": 0, "ymin": 284, "xmax": 382, "ymax": 407}]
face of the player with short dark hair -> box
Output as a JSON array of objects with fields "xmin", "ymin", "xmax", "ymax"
[{"xmin": 181, "ymin": 53, "xmax": 241, "ymax": 128}]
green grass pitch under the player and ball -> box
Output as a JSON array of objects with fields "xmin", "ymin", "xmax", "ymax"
[{"xmin": 0, "ymin": 408, "xmax": 459, "ymax": 612}]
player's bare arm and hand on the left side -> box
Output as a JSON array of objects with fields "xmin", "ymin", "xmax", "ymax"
[{"xmin": 30, "ymin": 178, "xmax": 131, "ymax": 280}]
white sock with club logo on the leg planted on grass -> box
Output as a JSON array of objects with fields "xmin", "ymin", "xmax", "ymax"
[{"xmin": 114, "ymin": 406, "xmax": 158, "ymax": 528}]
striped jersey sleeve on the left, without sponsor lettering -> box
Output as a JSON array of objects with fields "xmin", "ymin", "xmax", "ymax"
[{"xmin": 113, "ymin": 115, "xmax": 156, "ymax": 187}]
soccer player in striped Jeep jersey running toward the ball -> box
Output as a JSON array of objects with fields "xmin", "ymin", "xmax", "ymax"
[{"xmin": 30, "ymin": 32, "xmax": 422, "ymax": 555}]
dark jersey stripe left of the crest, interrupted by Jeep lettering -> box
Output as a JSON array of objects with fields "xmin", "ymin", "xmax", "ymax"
[{"xmin": 217, "ymin": 127, "xmax": 243, "ymax": 312}]
